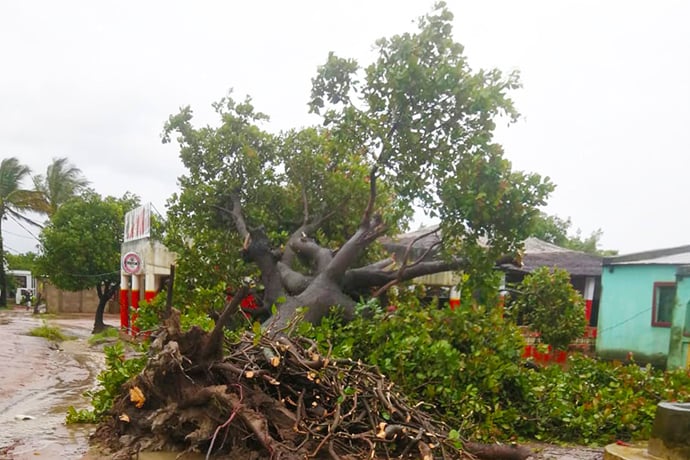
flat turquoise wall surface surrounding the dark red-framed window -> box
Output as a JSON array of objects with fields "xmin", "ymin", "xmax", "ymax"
[{"xmin": 596, "ymin": 265, "xmax": 676, "ymax": 366}]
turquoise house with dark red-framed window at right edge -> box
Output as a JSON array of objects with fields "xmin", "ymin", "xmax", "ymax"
[{"xmin": 596, "ymin": 245, "xmax": 690, "ymax": 368}]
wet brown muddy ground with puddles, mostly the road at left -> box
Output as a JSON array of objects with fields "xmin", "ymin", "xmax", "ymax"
[{"xmin": 0, "ymin": 310, "xmax": 603, "ymax": 460}]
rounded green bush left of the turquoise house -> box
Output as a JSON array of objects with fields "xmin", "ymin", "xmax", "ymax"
[{"xmin": 513, "ymin": 267, "xmax": 586, "ymax": 350}]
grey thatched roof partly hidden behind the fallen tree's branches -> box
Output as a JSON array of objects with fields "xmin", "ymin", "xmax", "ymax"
[{"xmin": 381, "ymin": 227, "xmax": 602, "ymax": 276}]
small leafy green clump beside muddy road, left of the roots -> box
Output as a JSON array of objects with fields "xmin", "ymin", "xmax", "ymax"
[{"xmin": 66, "ymin": 342, "xmax": 146, "ymax": 423}]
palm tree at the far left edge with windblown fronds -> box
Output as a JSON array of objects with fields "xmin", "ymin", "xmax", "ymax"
[{"xmin": 0, "ymin": 157, "xmax": 47, "ymax": 307}]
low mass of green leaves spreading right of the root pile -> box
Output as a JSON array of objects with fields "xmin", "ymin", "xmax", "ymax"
[{"xmin": 306, "ymin": 302, "xmax": 690, "ymax": 445}]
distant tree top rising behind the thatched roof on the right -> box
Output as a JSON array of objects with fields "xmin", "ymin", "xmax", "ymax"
[{"xmin": 530, "ymin": 212, "xmax": 618, "ymax": 256}]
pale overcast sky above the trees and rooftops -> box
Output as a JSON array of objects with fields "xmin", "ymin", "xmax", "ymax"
[{"xmin": 0, "ymin": 0, "xmax": 690, "ymax": 253}]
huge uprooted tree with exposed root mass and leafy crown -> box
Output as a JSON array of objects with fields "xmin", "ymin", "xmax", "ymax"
[{"xmin": 91, "ymin": 4, "xmax": 552, "ymax": 459}]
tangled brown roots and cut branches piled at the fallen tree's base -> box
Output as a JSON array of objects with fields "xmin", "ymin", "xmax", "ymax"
[{"xmin": 95, "ymin": 292, "xmax": 530, "ymax": 460}]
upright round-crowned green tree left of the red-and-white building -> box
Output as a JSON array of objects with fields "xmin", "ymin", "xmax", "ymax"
[{"xmin": 38, "ymin": 192, "xmax": 139, "ymax": 333}]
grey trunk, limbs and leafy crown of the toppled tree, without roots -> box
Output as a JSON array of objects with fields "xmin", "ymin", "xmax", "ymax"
[{"xmin": 164, "ymin": 3, "xmax": 553, "ymax": 327}]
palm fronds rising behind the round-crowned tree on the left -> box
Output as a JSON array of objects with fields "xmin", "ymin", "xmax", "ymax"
[{"xmin": 34, "ymin": 158, "xmax": 89, "ymax": 216}]
